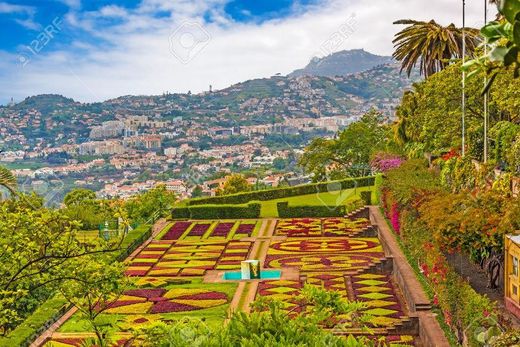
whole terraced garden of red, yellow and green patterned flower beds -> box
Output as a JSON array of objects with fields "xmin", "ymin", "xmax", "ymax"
[{"xmin": 43, "ymin": 211, "xmax": 416, "ymax": 347}]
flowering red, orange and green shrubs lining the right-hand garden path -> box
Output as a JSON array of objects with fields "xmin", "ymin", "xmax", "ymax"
[{"xmin": 381, "ymin": 160, "xmax": 520, "ymax": 345}]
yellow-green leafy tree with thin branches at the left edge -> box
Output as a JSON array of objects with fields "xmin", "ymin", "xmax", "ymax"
[{"xmin": 0, "ymin": 196, "xmax": 127, "ymax": 334}]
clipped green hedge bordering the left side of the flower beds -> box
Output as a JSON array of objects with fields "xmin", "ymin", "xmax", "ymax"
[{"xmin": 0, "ymin": 224, "xmax": 152, "ymax": 347}]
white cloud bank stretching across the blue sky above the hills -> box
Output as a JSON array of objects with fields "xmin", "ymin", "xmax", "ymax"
[{"xmin": 0, "ymin": 0, "xmax": 500, "ymax": 102}]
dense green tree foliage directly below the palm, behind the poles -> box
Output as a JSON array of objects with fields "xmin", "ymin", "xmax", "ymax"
[{"xmin": 394, "ymin": 63, "xmax": 520, "ymax": 160}]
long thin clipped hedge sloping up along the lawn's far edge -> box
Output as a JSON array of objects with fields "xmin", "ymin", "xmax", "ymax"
[{"xmin": 187, "ymin": 176, "xmax": 375, "ymax": 206}]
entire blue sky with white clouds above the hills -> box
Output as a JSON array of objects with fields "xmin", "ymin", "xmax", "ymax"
[{"xmin": 0, "ymin": 0, "xmax": 494, "ymax": 104}]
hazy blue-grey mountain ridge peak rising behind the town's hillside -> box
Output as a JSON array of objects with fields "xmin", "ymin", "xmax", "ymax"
[{"xmin": 288, "ymin": 49, "xmax": 393, "ymax": 77}]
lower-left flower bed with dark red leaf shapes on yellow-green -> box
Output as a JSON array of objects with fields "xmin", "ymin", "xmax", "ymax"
[{"xmin": 53, "ymin": 277, "xmax": 237, "ymax": 342}]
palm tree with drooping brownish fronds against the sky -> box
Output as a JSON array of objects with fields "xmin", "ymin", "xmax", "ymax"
[{"xmin": 392, "ymin": 19, "xmax": 479, "ymax": 77}]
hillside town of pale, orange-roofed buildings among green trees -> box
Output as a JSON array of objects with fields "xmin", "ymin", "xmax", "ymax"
[{"xmin": 0, "ymin": 61, "xmax": 411, "ymax": 203}]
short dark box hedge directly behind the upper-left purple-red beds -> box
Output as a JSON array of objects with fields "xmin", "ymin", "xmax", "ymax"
[{"xmin": 172, "ymin": 203, "xmax": 262, "ymax": 219}]
